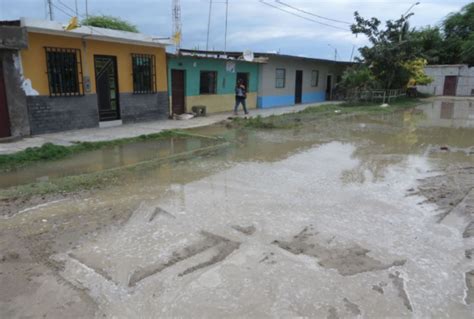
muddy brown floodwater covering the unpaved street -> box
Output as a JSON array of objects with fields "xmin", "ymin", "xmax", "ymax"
[{"xmin": 0, "ymin": 100, "xmax": 474, "ymax": 318}]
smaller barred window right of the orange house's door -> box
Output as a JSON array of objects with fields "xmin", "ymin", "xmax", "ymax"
[{"xmin": 132, "ymin": 54, "xmax": 156, "ymax": 94}]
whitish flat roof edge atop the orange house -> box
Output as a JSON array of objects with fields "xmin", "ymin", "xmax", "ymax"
[{"xmin": 20, "ymin": 18, "xmax": 171, "ymax": 47}]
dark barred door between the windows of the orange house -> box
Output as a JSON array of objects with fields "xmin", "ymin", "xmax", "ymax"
[{"xmin": 94, "ymin": 55, "xmax": 120, "ymax": 121}]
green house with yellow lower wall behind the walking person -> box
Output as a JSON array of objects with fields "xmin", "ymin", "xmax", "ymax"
[{"xmin": 168, "ymin": 50, "xmax": 259, "ymax": 114}]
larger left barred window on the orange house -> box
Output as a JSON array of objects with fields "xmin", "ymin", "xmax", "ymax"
[{"xmin": 45, "ymin": 47, "xmax": 84, "ymax": 96}]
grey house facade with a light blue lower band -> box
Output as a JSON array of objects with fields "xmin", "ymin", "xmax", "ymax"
[{"xmin": 255, "ymin": 53, "xmax": 351, "ymax": 108}]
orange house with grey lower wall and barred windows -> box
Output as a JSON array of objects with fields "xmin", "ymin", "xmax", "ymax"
[{"xmin": 0, "ymin": 18, "xmax": 169, "ymax": 135}]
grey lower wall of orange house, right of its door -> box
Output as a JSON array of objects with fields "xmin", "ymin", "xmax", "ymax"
[{"xmin": 120, "ymin": 91, "xmax": 169, "ymax": 123}]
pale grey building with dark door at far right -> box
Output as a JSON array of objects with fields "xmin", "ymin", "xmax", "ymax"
[{"xmin": 417, "ymin": 64, "xmax": 474, "ymax": 96}]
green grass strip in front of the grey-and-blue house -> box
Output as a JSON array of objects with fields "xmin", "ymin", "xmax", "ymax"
[{"xmin": 230, "ymin": 98, "xmax": 420, "ymax": 129}]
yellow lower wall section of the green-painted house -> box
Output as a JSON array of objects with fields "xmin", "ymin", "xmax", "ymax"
[{"xmin": 186, "ymin": 93, "xmax": 257, "ymax": 113}]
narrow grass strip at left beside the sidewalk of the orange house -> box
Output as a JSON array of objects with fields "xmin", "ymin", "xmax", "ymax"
[{"xmin": 0, "ymin": 130, "xmax": 209, "ymax": 172}]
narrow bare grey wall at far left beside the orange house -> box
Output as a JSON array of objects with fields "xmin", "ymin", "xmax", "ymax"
[{"xmin": 0, "ymin": 49, "xmax": 30, "ymax": 136}]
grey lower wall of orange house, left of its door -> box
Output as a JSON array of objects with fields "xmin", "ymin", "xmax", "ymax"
[{"xmin": 27, "ymin": 94, "xmax": 99, "ymax": 134}]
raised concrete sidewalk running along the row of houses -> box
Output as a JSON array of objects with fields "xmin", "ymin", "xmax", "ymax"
[{"xmin": 0, "ymin": 101, "xmax": 338, "ymax": 154}]
